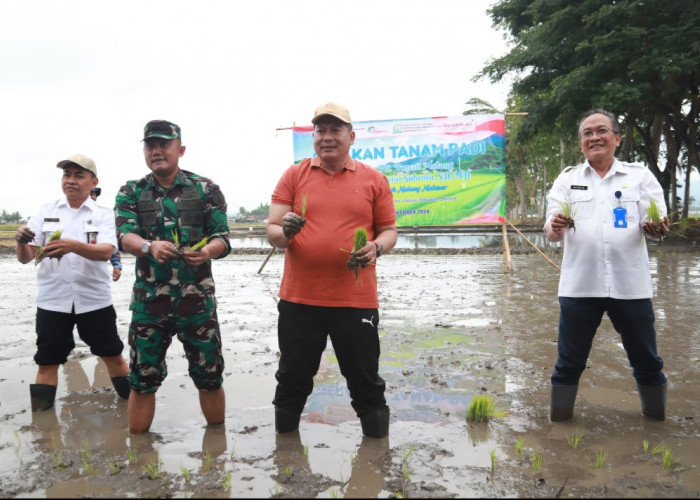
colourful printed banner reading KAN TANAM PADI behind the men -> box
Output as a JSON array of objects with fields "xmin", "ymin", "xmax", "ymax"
[{"xmin": 293, "ymin": 114, "xmax": 506, "ymax": 226}]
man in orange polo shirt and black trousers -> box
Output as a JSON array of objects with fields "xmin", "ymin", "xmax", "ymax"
[{"xmin": 267, "ymin": 103, "xmax": 397, "ymax": 438}]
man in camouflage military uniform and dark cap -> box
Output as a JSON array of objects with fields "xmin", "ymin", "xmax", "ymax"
[{"xmin": 115, "ymin": 120, "xmax": 231, "ymax": 433}]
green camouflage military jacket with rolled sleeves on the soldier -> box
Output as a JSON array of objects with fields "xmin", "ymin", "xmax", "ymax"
[{"xmin": 114, "ymin": 170, "xmax": 231, "ymax": 314}]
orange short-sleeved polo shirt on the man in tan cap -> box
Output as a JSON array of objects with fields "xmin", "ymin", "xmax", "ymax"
[{"xmin": 272, "ymin": 157, "xmax": 396, "ymax": 308}]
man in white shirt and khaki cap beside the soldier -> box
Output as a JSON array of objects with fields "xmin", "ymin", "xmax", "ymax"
[{"xmin": 15, "ymin": 154, "xmax": 130, "ymax": 411}]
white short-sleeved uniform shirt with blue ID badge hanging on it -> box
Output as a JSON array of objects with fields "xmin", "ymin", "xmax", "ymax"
[{"xmin": 546, "ymin": 160, "xmax": 666, "ymax": 299}]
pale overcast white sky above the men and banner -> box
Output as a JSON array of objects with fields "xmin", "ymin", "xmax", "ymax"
[{"xmin": 0, "ymin": 0, "xmax": 508, "ymax": 217}]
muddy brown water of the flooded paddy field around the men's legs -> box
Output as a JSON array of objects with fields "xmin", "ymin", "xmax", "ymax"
[{"xmin": 0, "ymin": 252, "xmax": 700, "ymax": 498}]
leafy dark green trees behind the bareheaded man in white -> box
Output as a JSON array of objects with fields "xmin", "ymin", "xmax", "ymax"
[{"xmin": 474, "ymin": 0, "xmax": 700, "ymax": 220}]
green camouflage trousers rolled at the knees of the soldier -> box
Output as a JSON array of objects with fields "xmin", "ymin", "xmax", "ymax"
[{"xmin": 129, "ymin": 309, "xmax": 224, "ymax": 393}]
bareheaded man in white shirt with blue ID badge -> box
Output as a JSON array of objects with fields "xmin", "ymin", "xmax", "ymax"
[{"xmin": 544, "ymin": 109, "xmax": 668, "ymax": 422}]
